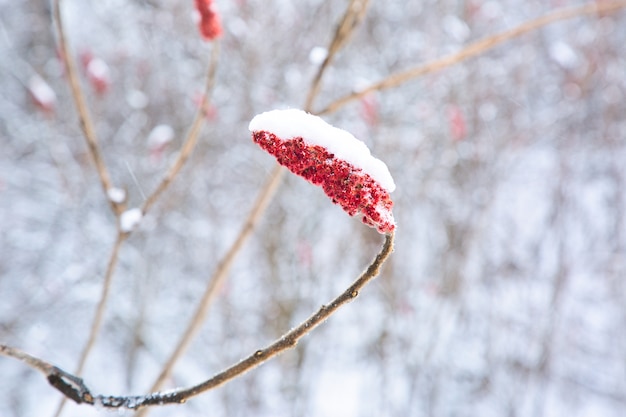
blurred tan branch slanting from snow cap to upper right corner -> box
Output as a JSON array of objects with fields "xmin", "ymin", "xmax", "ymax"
[{"xmin": 318, "ymin": 0, "xmax": 626, "ymax": 114}]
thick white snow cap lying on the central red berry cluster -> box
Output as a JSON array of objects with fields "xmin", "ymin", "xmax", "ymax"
[{"xmin": 248, "ymin": 109, "xmax": 396, "ymax": 192}]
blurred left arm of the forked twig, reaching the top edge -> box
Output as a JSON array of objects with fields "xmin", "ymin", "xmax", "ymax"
[{"xmin": 53, "ymin": 0, "xmax": 123, "ymax": 217}]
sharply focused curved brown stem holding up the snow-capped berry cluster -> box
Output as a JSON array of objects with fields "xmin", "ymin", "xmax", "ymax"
[{"xmin": 0, "ymin": 234, "xmax": 394, "ymax": 409}]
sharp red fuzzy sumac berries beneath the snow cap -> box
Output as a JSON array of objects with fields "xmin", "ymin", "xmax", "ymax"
[{"xmin": 252, "ymin": 131, "xmax": 396, "ymax": 233}]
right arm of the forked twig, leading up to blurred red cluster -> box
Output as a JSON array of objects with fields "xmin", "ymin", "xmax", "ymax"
[{"xmin": 141, "ymin": 42, "xmax": 219, "ymax": 214}]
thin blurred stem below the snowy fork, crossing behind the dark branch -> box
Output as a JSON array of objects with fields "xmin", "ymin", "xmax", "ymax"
[{"xmin": 54, "ymin": 229, "xmax": 128, "ymax": 417}]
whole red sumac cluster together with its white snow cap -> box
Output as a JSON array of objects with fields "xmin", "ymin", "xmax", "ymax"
[{"xmin": 249, "ymin": 109, "xmax": 396, "ymax": 233}]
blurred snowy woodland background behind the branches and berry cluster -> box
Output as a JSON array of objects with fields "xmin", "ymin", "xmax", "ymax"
[{"xmin": 0, "ymin": 0, "xmax": 626, "ymax": 417}]
